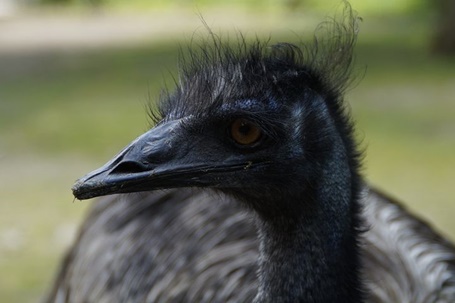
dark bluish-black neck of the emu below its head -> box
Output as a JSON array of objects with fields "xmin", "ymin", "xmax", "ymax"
[{"xmin": 254, "ymin": 169, "xmax": 362, "ymax": 303}]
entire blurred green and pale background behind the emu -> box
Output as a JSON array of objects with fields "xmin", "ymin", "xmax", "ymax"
[{"xmin": 0, "ymin": 0, "xmax": 455, "ymax": 302}]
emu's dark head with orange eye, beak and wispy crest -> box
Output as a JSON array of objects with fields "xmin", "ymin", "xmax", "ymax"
[{"xmin": 73, "ymin": 11, "xmax": 362, "ymax": 218}]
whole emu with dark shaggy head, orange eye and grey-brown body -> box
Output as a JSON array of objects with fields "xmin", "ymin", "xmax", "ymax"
[{"xmin": 48, "ymin": 8, "xmax": 455, "ymax": 303}]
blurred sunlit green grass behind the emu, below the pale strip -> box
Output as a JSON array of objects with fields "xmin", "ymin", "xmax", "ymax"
[{"xmin": 0, "ymin": 8, "xmax": 455, "ymax": 302}]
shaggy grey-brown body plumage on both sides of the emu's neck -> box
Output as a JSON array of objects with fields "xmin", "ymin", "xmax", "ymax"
[{"xmin": 49, "ymin": 188, "xmax": 455, "ymax": 303}]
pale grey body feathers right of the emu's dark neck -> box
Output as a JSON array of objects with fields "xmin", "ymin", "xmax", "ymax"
[{"xmin": 363, "ymin": 192, "xmax": 455, "ymax": 303}]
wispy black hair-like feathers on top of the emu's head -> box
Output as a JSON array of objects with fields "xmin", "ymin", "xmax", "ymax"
[{"xmin": 151, "ymin": 3, "xmax": 360, "ymax": 122}]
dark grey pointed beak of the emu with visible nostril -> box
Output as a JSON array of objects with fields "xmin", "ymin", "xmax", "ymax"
[{"xmin": 72, "ymin": 120, "xmax": 255, "ymax": 200}]
